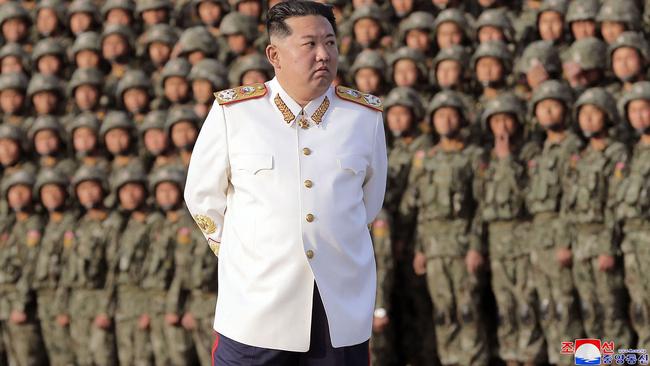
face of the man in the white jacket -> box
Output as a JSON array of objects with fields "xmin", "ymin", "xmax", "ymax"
[{"xmin": 267, "ymin": 15, "xmax": 338, "ymax": 96}]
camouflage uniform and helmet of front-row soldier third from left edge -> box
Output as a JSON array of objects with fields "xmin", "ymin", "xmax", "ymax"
[{"xmin": 57, "ymin": 166, "xmax": 117, "ymax": 366}]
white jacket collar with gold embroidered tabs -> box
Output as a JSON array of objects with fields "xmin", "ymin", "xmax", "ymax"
[{"xmin": 269, "ymin": 77, "xmax": 333, "ymax": 127}]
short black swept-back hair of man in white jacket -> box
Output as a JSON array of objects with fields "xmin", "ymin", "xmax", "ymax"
[{"xmin": 266, "ymin": 0, "xmax": 336, "ymax": 38}]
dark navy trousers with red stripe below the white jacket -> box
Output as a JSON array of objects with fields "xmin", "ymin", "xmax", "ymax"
[{"xmin": 212, "ymin": 284, "xmax": 370, "ymax": 366}]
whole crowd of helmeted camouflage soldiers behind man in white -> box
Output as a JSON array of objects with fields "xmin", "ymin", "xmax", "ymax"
[{"xmin": 0, "ymin": 0, "xmax": 650, "ymax": 366}]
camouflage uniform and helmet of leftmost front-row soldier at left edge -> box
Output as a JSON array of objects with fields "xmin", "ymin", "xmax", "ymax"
[{"xmin": 0, "ymin": 171, "xmax": 46, "ymax": 365}]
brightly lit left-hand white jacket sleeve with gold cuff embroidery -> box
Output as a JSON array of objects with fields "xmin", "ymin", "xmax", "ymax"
[{"xmin": 184, "ymin": 101, "xmax": 230, "ymax": 249}]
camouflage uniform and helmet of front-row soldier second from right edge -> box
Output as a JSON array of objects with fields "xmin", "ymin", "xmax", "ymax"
[{"xmin": 561, "ymin": 88, "xmax": 632, "ymax": 348}]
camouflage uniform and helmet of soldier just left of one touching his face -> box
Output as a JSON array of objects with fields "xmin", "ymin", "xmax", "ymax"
[{"xmin": 400, "ymin": 92, "xmax": 489, "ymax": 365}]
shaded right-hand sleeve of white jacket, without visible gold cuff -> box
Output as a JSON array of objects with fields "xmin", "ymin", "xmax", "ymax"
[{"xmin": 363, "ymin": 112, "xmax": 388, "ymax": 225}]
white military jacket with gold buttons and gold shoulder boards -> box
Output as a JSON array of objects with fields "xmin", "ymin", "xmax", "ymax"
[{"xmin": 184, "ymin": 78, "xmax": 387, "ymax": 352}]
